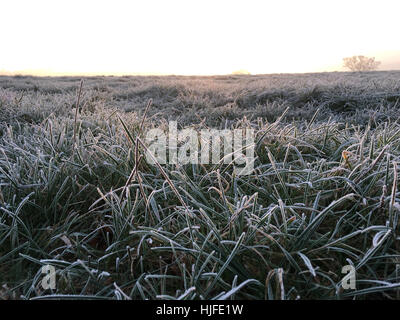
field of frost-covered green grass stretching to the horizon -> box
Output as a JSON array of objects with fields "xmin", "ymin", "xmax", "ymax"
[{"xmin": 0, "ymin": 72, "xmax": 400, "ymax": 300}]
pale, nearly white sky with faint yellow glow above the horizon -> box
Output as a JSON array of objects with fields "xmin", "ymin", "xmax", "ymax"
[{"xmin": 0, "ymin": 0, "xmax": 400, "ymax": 74}]
